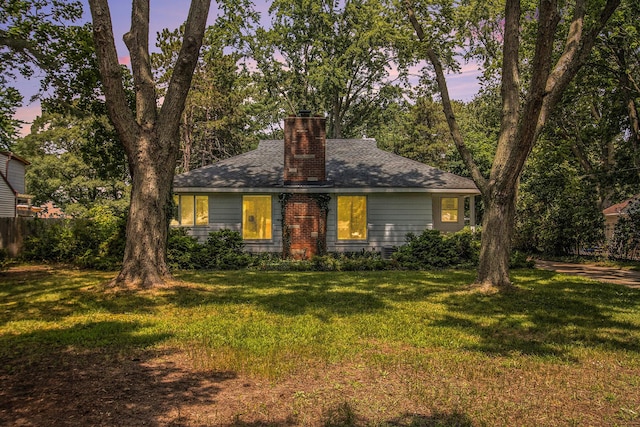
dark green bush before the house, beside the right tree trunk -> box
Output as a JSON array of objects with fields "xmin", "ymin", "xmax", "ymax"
[{"xmin": 392, "ymin": 229, "xmax": 480, "ymax": 270}]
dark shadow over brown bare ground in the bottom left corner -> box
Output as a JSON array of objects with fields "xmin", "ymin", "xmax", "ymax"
[{"xmin": 0, "ymin": 349, "xmax": 236, "ymax": 427}]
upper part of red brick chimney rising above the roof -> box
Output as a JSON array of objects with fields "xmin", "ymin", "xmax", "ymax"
[{"xmin": 284, "ymin": 111, "xmax": 327, "ymax": 185}]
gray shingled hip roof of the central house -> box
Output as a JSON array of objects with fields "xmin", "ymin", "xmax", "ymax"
[{"xmin": 174, "ymin": 139, "xmax": 478, "ymax": 193}]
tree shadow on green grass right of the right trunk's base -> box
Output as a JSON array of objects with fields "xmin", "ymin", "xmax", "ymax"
[{"xmin": 435, "ymin": 270, "xmax": 640, "ymax": 360}]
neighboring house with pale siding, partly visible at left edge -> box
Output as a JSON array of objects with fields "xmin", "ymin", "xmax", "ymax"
[{"xmin": 0, "ymin": 151, "xmax": 35, "ymax": 217}]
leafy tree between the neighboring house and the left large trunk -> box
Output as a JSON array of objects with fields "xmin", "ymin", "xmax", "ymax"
[{"xmin": 14, "ymin": 112, "xmax": 129, "ymax": 217}]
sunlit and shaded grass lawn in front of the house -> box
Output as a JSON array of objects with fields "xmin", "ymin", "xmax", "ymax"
[{"xmin": 0, "ymin": 268, "xmax": 640, "ymax": 426}]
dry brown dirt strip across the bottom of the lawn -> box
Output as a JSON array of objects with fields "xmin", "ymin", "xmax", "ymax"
[{"xmin": 0, "ymin": 350, "xmax": 640, "ymax": 427}]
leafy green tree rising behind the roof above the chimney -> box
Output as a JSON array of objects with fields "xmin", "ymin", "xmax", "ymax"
[{"xmin": 246, "ymin": 0, "xmax": 401, "ymax": 138}]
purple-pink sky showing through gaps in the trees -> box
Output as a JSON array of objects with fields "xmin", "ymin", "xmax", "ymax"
[{"xmin": 15, "ymin": 0, "xmax": 479, "ymax": 135}]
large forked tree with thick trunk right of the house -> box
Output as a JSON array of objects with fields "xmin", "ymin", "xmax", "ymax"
[{"xmin": 403, "ymin": 0, "xmax": 620, "ymax": 290}]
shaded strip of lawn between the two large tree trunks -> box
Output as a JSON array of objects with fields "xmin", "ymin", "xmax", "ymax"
[{"xmin": 168, "ymin": 271, "xmax": 472, "ymax": 318}]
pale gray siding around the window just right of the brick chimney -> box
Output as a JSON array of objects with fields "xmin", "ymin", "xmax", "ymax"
[{"xmin": 327, "ymin": 193, "xmax": 433, "ymax": 252}]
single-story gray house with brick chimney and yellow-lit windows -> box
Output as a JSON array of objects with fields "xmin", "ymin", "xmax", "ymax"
[{"xmin": 173, "ymin": 112, "xmax": 479, "ymax": 258}]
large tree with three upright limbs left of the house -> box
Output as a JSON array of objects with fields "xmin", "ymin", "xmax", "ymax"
[{"xmin": 89, "ymin": 0, "xmax": 211, "ymax": 287}]
